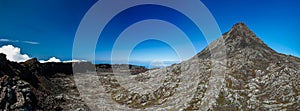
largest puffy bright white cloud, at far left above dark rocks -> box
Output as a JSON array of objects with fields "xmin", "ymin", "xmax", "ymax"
[{"xmin": 0, "ymin": 45, "xmax": 30, "ymax": 62}]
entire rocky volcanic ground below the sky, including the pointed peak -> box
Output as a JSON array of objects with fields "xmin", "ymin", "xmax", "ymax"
[{"xmin": 0, "ymin": 23, "xmax": 300, "ymax": 111}]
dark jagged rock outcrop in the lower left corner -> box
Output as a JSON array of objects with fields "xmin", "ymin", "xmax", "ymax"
[{"xmin": 0, "ymin": 54, "xmax": 36, "ymax": 111}]
